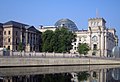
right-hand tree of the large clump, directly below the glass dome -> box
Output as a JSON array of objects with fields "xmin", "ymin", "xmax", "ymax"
[{"xmin": 54, "ymin": 27, "xmax": 75, "ymax": 53}]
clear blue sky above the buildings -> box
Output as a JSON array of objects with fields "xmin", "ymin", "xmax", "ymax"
[{"xmin": 0, "ymin": 0, "xmax": 120, "ymax": 44}]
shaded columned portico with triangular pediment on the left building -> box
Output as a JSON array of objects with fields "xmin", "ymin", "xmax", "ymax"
[{"xmin": 25, "ymin": 26, "xmax": 41, "ymax": 52}]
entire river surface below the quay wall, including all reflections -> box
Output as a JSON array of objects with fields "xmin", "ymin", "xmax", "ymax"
[{"xmin": 0, "ymin": 65, "xmax": 120, "ymax": 82}]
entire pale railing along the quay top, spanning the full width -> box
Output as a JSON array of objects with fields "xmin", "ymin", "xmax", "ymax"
[{"xmin": 0, "ymin": 51, "xmax": 120, "ymax": 60}]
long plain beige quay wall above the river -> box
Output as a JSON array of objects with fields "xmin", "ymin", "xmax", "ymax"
[{"xmin": 0, "ymin": 56, "xmax": 120, "ymax": 67}]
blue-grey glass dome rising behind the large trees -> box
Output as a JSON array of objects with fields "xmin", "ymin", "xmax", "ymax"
[{"xmin": 55, "ymin": 19, "xmax": 78, "ymax": 31}]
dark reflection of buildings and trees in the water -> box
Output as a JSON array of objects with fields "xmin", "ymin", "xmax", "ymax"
[{"xmin": 0, "ymin": 68, "xmax": 120, "ymax": 82}]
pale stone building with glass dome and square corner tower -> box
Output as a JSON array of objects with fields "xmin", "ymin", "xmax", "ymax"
[{"xmin": 39, "ymin": 18, "xmax": 118, "ymax": 57}]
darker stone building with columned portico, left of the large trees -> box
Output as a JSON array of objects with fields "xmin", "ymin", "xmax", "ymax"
[{"xmin": 3, "ymin": 21, "xmax": 41, "ymax": 51}]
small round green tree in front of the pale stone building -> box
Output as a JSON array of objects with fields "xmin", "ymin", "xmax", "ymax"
[{"xmin": 78, "ymin": 43, "xmax": 89, "ymax": 55}]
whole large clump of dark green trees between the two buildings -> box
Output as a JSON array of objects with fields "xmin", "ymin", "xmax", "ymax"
[{"xmin": 42, "ymin": 27, "xmax": 75, "ymax": 53}]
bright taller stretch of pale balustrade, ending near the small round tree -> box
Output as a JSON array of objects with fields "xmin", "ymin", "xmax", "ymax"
[{"xmin": 0, "ymin": 51, "xmax": 80, "ymax": 58}]
